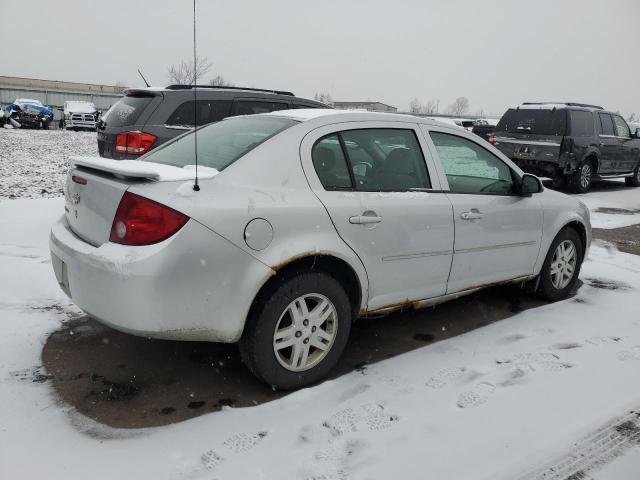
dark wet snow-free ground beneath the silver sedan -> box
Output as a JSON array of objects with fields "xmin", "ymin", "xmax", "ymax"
[{"xmin": 42, "ymin": 287, "xmax": 544, "ymax": 428}]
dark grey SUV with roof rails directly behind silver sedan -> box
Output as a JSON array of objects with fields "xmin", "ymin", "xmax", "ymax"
[{"xmin": 98, "ymin": 85, "xmax": 330, "ymax": 160}]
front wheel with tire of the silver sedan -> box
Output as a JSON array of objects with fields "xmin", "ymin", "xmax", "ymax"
[{"xmin": 538, "ymin": 227, "xmax": 584, "ymax": 302}]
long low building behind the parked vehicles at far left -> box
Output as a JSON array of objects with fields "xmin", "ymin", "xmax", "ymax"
[{"xmin": 0, "ymin": 76, "xmax": 126, "ymax": 126}]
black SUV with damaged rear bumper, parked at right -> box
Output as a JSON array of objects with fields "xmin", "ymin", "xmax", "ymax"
[{"xmin": 489, "ymin": 103, "xmax": 640, "ymax": 193}]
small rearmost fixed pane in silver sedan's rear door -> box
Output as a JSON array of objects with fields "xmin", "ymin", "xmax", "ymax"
[{"xmin": 311, "ymin": 133, "xmax": 353, "ymax": 190}]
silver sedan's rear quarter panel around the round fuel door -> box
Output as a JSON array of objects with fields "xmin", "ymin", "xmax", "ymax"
[{"xmin": 131, "ymin": 125, "xmax": 368, "ymax": 307}]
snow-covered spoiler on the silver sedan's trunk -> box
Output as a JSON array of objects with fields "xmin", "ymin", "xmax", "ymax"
[{"xmin": 71, "ymin": 157, "xmax": 219, "ymax": 182}]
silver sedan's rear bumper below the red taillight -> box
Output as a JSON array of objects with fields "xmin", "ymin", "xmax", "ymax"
[{"xmin": 49, "ymin": 216, "xmax": 272, "ymax": 343}]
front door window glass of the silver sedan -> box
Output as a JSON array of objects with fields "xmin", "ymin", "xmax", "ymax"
[{"xmin": 430, "ymin": 132, "xmax": 514, "ymax": 195}]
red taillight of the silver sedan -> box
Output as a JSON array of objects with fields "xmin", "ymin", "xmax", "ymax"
[{"xmin": 109, "ymin": 192, "xmax": 189, "ymax": 245}]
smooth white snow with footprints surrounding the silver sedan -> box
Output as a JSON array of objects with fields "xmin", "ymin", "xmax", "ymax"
[{"xmin": 0, "ymin": 198, "xmax": 640, "ymax": 480}]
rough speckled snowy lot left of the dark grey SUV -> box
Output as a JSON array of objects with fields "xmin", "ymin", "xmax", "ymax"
[{"xmin": 0, "ymin": 128, "xmax": 98, "ymax": 199}]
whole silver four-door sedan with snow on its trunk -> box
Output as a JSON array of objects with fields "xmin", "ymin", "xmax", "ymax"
[{"xmin": 50, "ymin": 110, "xmax": 591, "ymax": 389}]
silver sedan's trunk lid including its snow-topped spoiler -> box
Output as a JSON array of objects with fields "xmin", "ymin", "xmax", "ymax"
[{"xmin": 65, "ymin": 157, "xmax": 218, "ymax": 246}]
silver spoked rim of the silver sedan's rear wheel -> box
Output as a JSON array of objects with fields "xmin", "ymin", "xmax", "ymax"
[{"xmin": 273, "ymin": 293, "xmax": 338, "ymax": 372}]
